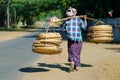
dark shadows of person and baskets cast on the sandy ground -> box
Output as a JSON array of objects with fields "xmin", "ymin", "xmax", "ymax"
[{"xmin": 19, "ymin": 63, "xmax": 92, "ymax": 73}]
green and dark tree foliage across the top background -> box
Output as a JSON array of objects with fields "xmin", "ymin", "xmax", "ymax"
[{"xmin": 0, "ymin": 0, "xmax": 120, "ymax": 26}]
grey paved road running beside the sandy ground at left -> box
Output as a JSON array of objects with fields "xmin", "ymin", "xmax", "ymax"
[{"xmin": 0, "ymin": 32, "xmax": 41, "ymax": 80}]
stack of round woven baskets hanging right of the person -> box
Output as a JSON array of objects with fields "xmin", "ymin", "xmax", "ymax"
[{"xmin": 87, "ymin": 25, "xmax": 113, "ymax": 43}]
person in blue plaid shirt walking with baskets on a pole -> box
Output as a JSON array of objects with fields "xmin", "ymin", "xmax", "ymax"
[{"xmin": 60, "ymin": 7, "xmax": 87, "ymax": 72}]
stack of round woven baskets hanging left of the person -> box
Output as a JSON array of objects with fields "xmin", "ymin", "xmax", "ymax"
[{"xmin": 32, "ymin": 33, "xmax": 62, "ymax": 55}]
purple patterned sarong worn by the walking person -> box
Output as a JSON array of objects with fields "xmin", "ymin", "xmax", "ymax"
[{"xmin": 68, "ymin": 39, "xmax": 82, "ymax": 66}]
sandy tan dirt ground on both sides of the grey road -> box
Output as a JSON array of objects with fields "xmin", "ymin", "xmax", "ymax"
[{"xmin": 0, "ymin": 33, "xmax": 120, "ymax": 80}]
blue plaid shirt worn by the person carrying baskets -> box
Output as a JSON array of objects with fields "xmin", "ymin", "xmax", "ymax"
[{"xmin": 60, "ymin": 17, "xmax": 87, "ymax": 42}]
